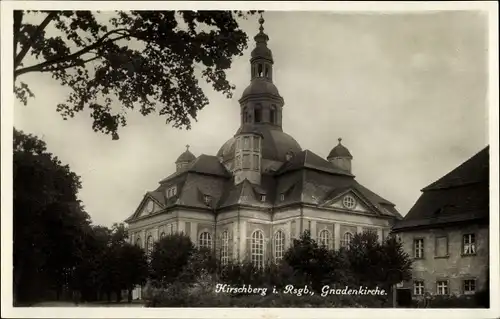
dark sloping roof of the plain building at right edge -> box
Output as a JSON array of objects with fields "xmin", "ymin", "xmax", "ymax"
[{"xmin": 393, "ymin": 147, "xmax": 489, "ymax": 231}]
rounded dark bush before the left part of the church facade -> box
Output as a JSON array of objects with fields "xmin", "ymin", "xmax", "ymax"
[{"xmin": 150, "ymin": 234, "xmax": 196, "ymax": 285}]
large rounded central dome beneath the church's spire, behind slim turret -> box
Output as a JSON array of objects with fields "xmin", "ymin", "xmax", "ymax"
[{"xmin": 217, "ymin": 125, "xmax": 302, "ymax": 162}]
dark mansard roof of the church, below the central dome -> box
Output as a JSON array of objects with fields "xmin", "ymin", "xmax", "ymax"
[{"xmin": 126, "ymin": 150, "xmax": 401, "ymax": 224}]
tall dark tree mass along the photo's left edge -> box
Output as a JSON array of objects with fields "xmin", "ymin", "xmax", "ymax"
[{"xmin": 13, "ymin": 129, "xmax": 90, "ymax": 302}]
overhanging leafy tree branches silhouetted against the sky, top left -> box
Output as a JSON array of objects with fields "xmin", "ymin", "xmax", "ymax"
[{"xmin": 13, "ymin": 11, "xmax": 262, "ymax": 139}]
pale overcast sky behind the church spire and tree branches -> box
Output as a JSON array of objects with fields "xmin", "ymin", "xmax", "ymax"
[{"xmin": 14, "ymin": 12, "xmax": 488, "ymax": 225}]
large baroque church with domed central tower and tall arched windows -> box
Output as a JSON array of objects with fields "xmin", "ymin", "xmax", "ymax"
[{"xmin": 125, "ymin": 17, "xmax": 401, "ymax": 266}]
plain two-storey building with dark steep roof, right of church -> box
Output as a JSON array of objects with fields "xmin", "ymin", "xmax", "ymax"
[{"xmin": 393, "ymin": 147, "xmax": 489, "ymax": 297}]
